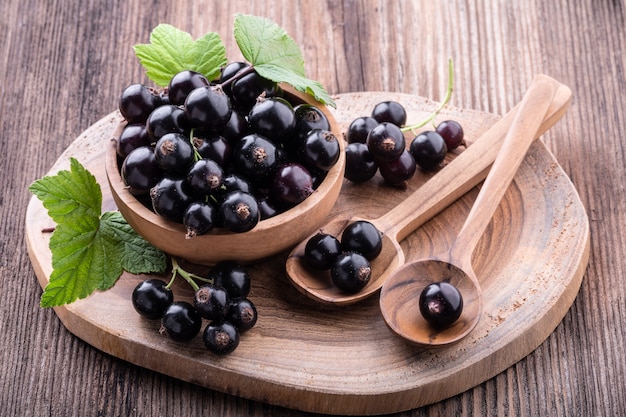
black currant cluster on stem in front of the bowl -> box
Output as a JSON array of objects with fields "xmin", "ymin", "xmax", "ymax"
[{"xmin": 132, "ymin": 259, "xmax": 257, "ymax": 355}]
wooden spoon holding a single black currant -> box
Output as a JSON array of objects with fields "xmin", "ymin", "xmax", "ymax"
[{"xmin": 380, "ymin": 76, "xmax": 558, "ymax": 346}]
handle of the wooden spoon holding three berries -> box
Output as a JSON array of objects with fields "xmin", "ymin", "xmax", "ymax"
[{"xmin": 375, "ymin": 76, "xmax": 572, "ymax": 242}]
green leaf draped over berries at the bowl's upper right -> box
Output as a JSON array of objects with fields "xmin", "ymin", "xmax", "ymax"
[{"xmin": 233, "ymin": 14, "xmax": 335, "ymax": 107}]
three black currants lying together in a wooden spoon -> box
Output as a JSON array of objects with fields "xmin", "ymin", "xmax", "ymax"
[{"xmin": 304, "ymin": 220, "xmax": 383, "ymax": 294}]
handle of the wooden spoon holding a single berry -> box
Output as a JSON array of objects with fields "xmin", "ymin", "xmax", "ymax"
[{"xmin": 450, "ymin": 75, "xmax": 559, "ymax": 262}]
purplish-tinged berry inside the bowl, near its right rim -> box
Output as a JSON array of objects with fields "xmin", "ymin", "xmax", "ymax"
[{"xmin": 271, "ymin": 162, "xmax": 313, "ymax": 206}]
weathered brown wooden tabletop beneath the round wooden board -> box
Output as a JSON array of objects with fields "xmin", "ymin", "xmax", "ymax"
[{"xmin": 0, "ymin": 0, "xmax": 626, "ymax": 417}]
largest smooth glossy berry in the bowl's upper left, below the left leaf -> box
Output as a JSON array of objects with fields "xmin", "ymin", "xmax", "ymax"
[{"xmin": 185, "ymin": 86, "xmax": 232, "ymax": 132}]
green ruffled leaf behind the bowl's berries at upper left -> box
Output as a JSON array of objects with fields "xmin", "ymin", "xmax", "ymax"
[{"xmin": 133, "ymin": 24, "xmax": 227, "ymax": 87}]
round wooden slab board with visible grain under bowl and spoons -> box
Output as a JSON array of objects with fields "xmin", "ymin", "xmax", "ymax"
[{"xmin": 26, "ymin": 92, "xmax": 589, "ymax": 415}]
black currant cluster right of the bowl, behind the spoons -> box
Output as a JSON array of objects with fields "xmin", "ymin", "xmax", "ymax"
[{"xmin": 344, "ymin": 101, "xmax": 464, "ymax": 187}]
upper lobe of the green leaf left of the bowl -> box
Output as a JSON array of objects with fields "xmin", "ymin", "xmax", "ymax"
[{"xmin": 28, "ymin": 158, "xmax": 102, "ymax": 223}]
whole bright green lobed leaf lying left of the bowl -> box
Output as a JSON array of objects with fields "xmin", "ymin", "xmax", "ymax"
[{"xmin": 29, "ymin": 158, "xmax": 167, "ymax": 307}]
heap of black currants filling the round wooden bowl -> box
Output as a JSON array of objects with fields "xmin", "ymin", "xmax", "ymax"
[{"xmin": 117, "ymin": 62, "xmax": 341, "ymax": 238}]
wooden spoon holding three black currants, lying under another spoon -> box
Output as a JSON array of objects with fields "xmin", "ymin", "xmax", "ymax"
[{"xmin": 286, "ymin": 77, "xmax": 572, "ymax": 305}]
